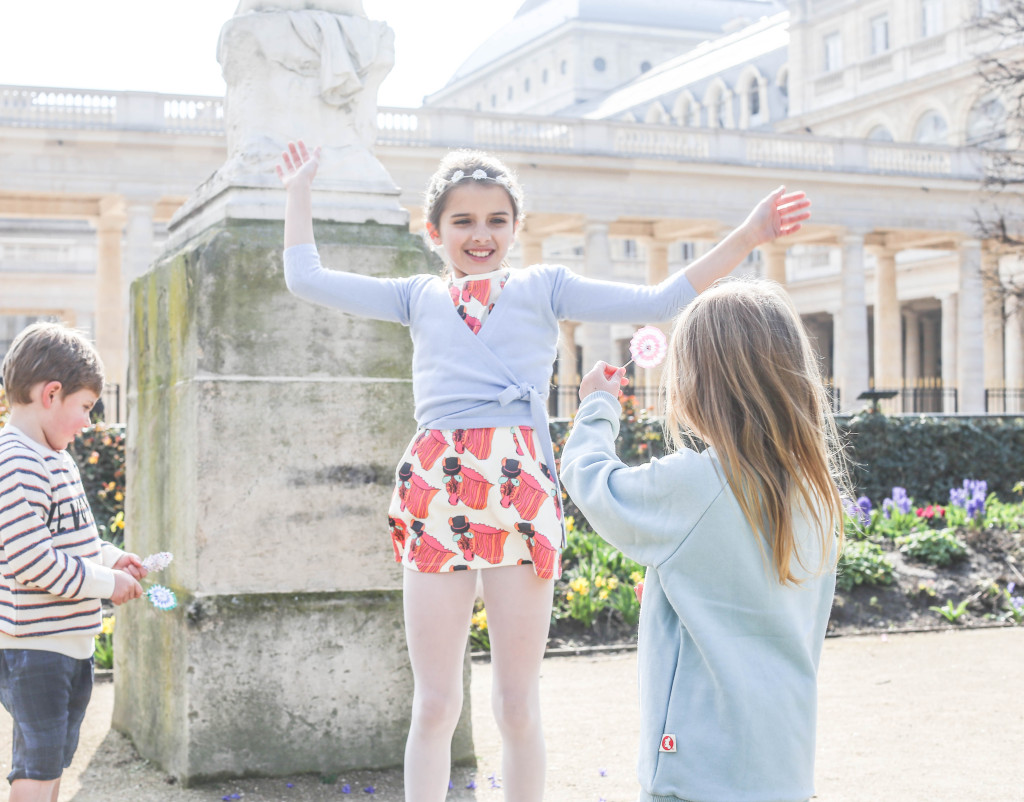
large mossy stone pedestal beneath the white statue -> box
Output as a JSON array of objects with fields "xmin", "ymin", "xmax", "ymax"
[{"xmin": 114, "ymin": 220, "xmax": 472, "ymax": 784}]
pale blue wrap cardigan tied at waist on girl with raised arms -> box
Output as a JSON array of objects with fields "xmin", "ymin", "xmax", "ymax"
[{"xmin": 285, "ymin": 245, "xmax": 696, "ymax": 520}]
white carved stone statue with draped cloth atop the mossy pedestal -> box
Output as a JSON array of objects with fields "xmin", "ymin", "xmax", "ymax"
[{"xmin": 217, "ymin": 0, "xmax": 394, "ymax": 192}]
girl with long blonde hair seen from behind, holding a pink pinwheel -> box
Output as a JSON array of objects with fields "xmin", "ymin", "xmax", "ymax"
[{"xmin": 562, "ymin": 281, "xmax": 846, "ymax": 802}]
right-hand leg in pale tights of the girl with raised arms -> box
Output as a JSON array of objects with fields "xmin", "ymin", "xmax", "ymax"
[{"xmin": 480, "ymin": 565, "xmax": 555, "ymax": 802}]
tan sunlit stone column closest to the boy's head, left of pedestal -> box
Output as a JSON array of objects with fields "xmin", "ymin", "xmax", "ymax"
[{"xmin": 94, "ymin": 196, "xmax": 128, "ymax": 395}]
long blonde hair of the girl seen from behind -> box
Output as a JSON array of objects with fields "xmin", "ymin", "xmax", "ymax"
[{"xmin": 665, "ymin": 280, "xmax": 848, "ymax": 585}]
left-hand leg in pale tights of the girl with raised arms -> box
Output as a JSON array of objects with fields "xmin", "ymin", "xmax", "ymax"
[{"xmin": 402, "ymin": 568, "xmax": 476, "ymax": 802}]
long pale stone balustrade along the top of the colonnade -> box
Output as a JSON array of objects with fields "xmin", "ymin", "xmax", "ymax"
[{"xmin": 0, "ymin": 86, "xmax": 984, "ymax": 181}]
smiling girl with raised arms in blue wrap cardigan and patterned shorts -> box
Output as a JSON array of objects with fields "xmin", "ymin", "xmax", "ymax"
[{"xmin": 278, "ymin": 141, "xmax": 810, "ymax": 802}]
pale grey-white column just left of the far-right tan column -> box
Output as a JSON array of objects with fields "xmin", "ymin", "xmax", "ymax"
[{"xmin": 956, "ymin": 240, "xmax": 985, "ymax": 415}]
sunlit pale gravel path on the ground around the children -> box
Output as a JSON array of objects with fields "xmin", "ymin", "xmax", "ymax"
[{"xmin": 0, "ymin": 628, "xmax": 1024, "ymax": 802}]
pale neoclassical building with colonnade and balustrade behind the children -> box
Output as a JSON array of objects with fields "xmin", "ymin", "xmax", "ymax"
[{"xmin": 0, "ymin": 0, "xmax": 1024, "ymax": 414}]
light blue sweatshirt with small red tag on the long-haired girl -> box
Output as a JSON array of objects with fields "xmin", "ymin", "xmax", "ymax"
[{"xmin": 562, "ymin": 392, "xmax": 836, "ymax": 802}]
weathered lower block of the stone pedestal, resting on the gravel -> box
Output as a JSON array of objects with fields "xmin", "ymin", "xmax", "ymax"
[{"xmin": 114, "ymin": 592, "xmax": 472, "ymax": 785}]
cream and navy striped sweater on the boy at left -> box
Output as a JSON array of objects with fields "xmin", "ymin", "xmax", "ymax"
[{"xmin": 0, "ymin": 423, "xmax": 124, "ymax": 660}]
